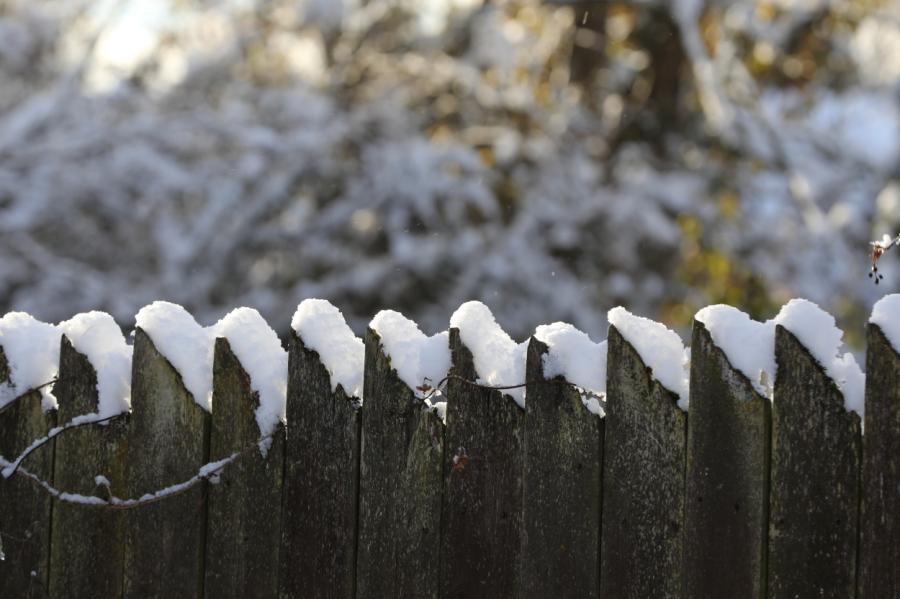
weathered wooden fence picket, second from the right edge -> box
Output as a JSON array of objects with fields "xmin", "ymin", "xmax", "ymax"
[{"xmin": 767, "ymin": 325, "xmax": 861, "ymax": 599}]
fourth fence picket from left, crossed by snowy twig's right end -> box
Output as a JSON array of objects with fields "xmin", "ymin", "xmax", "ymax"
[{"xmin": 204, "ymin": 338, "xmax": 284, "ymax": 599}]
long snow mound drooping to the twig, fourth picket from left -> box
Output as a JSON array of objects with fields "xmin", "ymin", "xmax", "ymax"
[{"xmin": 213, "ymin": 308, "xmax": 288, "ymax": 437}]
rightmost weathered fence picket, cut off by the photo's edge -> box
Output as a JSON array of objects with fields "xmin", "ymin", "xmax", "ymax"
[{"xmin": 859, "ymin": 323, "xmax": 900, "ymax": 599}]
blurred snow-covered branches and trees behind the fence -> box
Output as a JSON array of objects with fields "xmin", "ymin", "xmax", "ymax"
[{"xmin": 0, "ymin": 0, "xmax": 900, "ymax": 345}]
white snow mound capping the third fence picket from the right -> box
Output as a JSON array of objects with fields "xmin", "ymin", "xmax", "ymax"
[{"xmin": 694, "ymin": 304, "xmax": 775, "ymax": 398}]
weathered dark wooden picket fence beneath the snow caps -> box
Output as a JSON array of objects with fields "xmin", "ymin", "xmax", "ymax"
[{"xmin": 0, "ymin": 316, "xmax": 900, "ymax": 599}]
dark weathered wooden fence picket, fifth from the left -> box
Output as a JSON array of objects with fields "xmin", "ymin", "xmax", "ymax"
[{"xmin": 279, "ymin": 334, "xmax": 361, "ymax": 599}]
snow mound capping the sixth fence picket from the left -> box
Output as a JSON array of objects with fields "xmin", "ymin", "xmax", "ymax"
[{"xmin": 369, "ymin": 310, "xmax": 450, "ymax": 397}]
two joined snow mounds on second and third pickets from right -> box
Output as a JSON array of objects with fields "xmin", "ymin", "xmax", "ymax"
[{"xmin": 695, "ymin": 299, "xmax": 865, "ymax": 416}]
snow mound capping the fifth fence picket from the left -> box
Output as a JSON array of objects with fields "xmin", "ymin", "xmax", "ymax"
[{"xmin": 291, "ymin": 299, "xmax": 366, "ymax": 400}]
